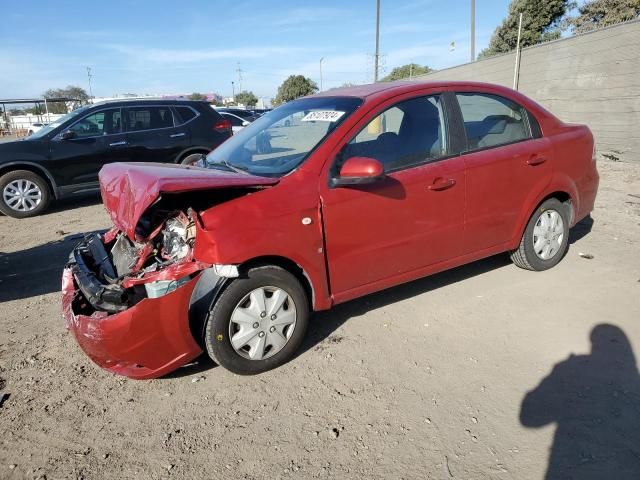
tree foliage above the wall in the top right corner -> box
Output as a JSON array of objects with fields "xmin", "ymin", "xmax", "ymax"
[{"xmin": 566, "ymin": 0, "xmax": 640, "ymax": 33}]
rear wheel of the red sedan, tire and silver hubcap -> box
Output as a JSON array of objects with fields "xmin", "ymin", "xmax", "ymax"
[{"xmin": 511, "ymin": 198, "xmax": 570, "ymax": 272}]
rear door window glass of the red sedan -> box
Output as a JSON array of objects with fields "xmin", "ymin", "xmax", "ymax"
[{"xmin": 456, "ymin": 93, "xmax": 531, "ymax": 150}]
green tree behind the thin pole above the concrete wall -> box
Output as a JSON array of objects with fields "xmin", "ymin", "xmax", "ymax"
[{"xmin": 478, "ymin": 0, "xmax": 573, "ymax": 58}]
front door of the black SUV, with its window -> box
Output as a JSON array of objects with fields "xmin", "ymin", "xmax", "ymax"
[{"xmin": 50, "ymin": 107, "xmax": 129, "ymax": 186}]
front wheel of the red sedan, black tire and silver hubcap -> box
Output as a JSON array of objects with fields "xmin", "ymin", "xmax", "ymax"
[{"xmin": 204, "ymin": 266, "xmax": 310, "ymax": 375}]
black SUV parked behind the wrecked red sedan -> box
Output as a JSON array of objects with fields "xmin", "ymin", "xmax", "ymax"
[{"xmin": 0, "ymin": 100, "xmax": 231, "ymax": 218}]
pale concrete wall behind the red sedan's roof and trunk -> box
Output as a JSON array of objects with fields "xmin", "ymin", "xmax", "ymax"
[{"xmin": 418, "ymin": 20, "xmax": 640, "ymax": 162}]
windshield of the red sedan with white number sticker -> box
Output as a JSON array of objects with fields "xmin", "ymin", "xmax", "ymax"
[{"xmin": 207, "ymin": 97, "xmax": 362, "ymax": 177}]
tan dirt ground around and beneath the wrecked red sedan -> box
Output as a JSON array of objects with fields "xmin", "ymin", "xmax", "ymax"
[{"xmin": 0, "ymin": 162, "xmax": 640, "ymax": 479}]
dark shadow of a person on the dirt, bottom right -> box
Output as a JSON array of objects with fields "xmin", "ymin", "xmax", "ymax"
[{"xmin": 520, "ymin": 324, "xmax": 640, "ymax": 480}]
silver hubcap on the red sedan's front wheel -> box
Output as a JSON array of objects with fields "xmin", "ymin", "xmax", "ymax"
[{"xmin": 229, "ymin": 287, "xmax": 296, "ymax": 360}]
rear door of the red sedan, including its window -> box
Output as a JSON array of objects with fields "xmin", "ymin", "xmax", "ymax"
[{"xmin": 456, "ymin": 92, "xmax": 553, "ymax": 253}]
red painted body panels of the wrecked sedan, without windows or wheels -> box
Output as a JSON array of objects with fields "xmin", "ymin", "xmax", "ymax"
[{"xmin": 63, "ymin": 82, "xmax": 598, "ymax": 378}]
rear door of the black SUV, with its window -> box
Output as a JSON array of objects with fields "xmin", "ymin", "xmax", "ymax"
[{"xmin": 124, "ymin": 105, "xmax": 190, "ymax": 163}]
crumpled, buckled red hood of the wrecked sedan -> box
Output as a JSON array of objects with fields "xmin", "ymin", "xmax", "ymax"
[{"xmin": 100, "ymin": 163, "xmax": 278, "ymax": 240}]
